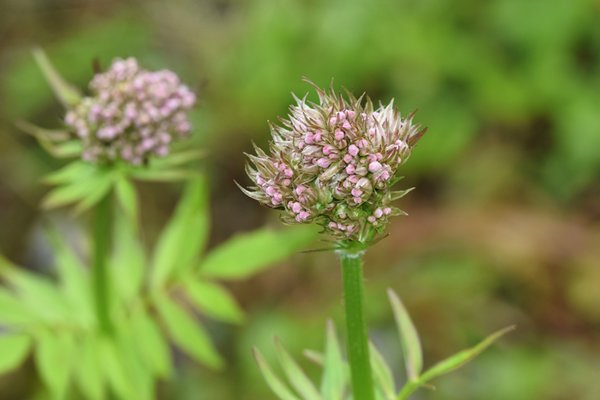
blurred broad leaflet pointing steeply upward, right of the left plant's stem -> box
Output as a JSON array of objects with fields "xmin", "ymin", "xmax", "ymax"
[{"xmin": 152, "ymin": 178, "xmax": 209, "ymax": 287}]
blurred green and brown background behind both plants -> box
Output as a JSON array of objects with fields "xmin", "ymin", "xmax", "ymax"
[{"xmin": 0, "ymin": 0, "xmax": 600, "ymax": 400}]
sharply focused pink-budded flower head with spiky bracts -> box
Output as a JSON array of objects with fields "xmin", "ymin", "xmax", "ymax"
[{"xmin": 243, "ymin": 83, "xmax": 425, "ymax": 243}]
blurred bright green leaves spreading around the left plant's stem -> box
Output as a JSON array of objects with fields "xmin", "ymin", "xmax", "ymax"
[{"xmin": 0, "ymin": 179, "xmax": 314, "ymax": 400}]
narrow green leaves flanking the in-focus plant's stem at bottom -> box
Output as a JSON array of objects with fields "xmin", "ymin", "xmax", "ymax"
[{"xmin": 254, "ymin": 289, "xmax": 514, "ymax": 400}]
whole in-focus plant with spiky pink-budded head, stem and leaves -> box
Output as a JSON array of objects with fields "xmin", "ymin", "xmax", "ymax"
[{"xmin": 241, "ymin": 82, "xmax": 510, "ymax": 400}]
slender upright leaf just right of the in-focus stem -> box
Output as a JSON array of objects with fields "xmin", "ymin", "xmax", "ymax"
[{"xmin": 388, "ymin": 289, "xmax": 423, "ymax": 380}]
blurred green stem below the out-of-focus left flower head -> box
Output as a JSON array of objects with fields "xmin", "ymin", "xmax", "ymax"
[{"xmin": 92, "ymin": 193, "xmax": 112, "ymax": 333}]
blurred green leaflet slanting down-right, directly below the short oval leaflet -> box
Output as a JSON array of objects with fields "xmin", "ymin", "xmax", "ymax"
[{"xmin": 155, "ymin": 294, "xmax": 223, "ymax": 369}]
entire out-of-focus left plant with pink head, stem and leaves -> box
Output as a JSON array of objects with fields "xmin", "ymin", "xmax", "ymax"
[{"xmin": 0, "ymin": 51, "xmax": 314, "ymax": 400}]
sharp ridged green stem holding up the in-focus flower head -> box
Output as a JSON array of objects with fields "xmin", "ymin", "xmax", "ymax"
[{"xmin": 339, "ymin": 250, "xmax": 374, "ymax": 400}]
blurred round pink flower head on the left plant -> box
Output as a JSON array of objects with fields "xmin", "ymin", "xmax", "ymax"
[{"xmin": 65, "ymin": 58, "xmax": 196, "ymax": 165}]
